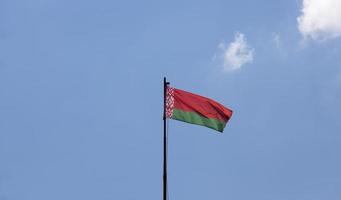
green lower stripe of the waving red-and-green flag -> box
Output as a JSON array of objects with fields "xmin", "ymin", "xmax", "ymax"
[{"xmin": 172, "ymin": 108, "xmax": 226, "ymax": 132}]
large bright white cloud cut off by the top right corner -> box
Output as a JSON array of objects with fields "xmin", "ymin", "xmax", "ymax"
[{"xmin": 297, "ymin": 0, "xmax": 341, "ymax": 40}]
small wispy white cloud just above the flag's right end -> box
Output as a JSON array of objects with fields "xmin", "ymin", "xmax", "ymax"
[{"xmin": 214, "ymin": 32, "xmax": 254, "ymax": 71}]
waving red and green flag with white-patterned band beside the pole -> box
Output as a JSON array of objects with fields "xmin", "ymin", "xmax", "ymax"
[{"xmin": 166, "ymin": 87, "xmax": 233, "ymax": 132}]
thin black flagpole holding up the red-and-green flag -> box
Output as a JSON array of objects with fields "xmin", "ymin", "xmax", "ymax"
[{"xmin": 163, "ymin": 77, "xmax": 169, "ymax": 200}]
